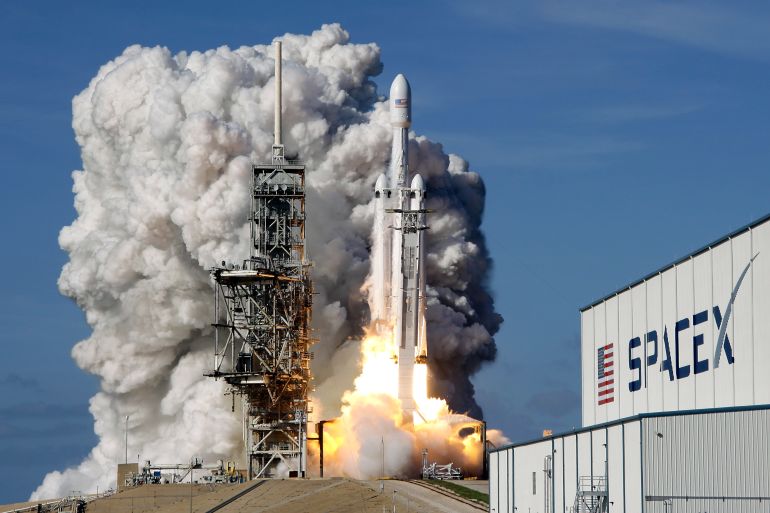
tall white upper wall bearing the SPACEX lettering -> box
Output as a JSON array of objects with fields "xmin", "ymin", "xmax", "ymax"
[{"xmin": 581, "ymin": 221, "xmax": 770, "ymax": 426}]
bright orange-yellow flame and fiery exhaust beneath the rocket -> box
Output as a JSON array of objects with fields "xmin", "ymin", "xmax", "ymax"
[{"xmin": 310, "ymin": 330, "xmax": 505, "ymax": 479}]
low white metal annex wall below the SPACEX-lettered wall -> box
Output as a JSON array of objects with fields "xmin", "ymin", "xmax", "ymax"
[{"xmin": 490, "ymin": 409, "xmax": 770, "ymax": 513}]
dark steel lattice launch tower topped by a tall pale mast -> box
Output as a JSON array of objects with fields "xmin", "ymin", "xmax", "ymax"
[{"xmin": 207, "ymin": 42, "xmax": 313, "ymax": 479}]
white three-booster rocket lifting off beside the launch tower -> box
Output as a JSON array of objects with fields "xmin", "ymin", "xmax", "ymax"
[{"xmin": 371, "ymin": 74, "xmax": 427, "ymax": 412}]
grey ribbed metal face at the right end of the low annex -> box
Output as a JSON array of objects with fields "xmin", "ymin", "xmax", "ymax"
[{"xmin": 642, "ymin": 410, "xmax": 770, "ymax": 513}]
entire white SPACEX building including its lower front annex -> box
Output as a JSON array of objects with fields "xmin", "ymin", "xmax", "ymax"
[{"xmin": 489, "ymin": 216, "xmax": 770, "ymax": 513}]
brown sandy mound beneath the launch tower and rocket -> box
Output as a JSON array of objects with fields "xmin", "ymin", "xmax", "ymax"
[{"xmin": 0, "ymin": 478, "xmax": 486, "ymax": 513}]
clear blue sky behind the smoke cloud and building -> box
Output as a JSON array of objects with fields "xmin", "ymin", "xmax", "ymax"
[{"xmin": 0, "ymin": 0, "xmax": 770, "ymax": 503}]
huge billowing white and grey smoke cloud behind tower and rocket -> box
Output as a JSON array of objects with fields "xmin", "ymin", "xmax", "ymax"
[{"xmin": 32, "ymin": 25, "xmax": 501, "ymax": 498}]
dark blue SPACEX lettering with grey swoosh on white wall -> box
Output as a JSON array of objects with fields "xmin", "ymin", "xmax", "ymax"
[{"xmin": 628, "ymin": 254, "xmax": 759, "ymax": 392}]
